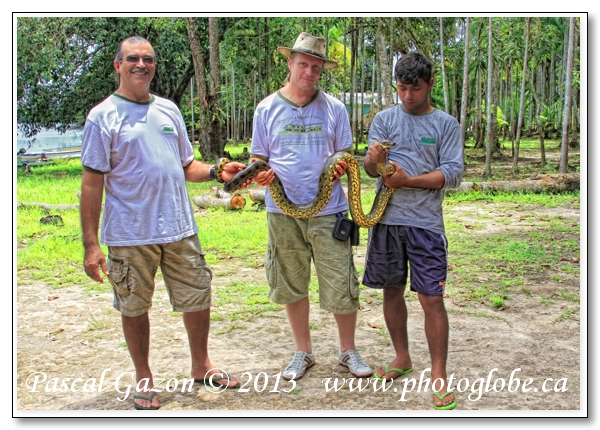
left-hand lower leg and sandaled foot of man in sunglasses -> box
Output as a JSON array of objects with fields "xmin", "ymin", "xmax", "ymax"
[{"xmin": 121, "ymin": 312, "xmax": 160, "ymax": 408}]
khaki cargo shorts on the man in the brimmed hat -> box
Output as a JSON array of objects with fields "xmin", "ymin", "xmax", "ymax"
[{"xmin": 265, "ymin": 213, "xmax": 360, "ymax": 314}]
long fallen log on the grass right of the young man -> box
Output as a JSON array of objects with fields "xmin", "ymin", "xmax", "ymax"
[{"xmin": 473, "ymin": 173, "xmax": 580, "ymax": 193}]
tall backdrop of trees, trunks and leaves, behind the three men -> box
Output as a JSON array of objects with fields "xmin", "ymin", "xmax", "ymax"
[{"xmin": 17, "ymin": 16, "xmax": 580, "ymax": 171}]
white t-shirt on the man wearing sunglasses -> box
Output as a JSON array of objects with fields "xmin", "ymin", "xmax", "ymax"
[{"xmin": 81, "ymin": 94, "xmax": 198, "ymax": 246}]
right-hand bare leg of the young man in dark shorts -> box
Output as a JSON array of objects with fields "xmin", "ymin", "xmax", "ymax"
[{"xmin": 419, "ymin": 294, "xmax": 454, "ymax": 406}]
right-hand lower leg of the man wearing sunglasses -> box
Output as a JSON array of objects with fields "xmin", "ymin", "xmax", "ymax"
[{"xmin": 183, "ymin": 308, "xmax": 238, "ymax": 387}]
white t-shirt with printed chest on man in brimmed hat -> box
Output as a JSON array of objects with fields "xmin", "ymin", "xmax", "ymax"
[{"xmin": 250, "ymin": 91, "xmax": 352, "ymax": 216}]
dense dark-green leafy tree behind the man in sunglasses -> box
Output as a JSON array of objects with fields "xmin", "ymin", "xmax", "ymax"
[{"xmin": 17, "ymin": 17, "xmax": 193, "ymax": 137}]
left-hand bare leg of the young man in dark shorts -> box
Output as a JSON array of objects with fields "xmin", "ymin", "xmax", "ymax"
[{"xmin": 377, "ymin": 286, "xmax": 412, "ymax": 380}]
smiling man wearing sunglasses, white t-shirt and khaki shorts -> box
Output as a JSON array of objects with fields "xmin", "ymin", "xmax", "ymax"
[{"xmin": 80, "ymin": 36, "xmax": 245, "ymax": 410}]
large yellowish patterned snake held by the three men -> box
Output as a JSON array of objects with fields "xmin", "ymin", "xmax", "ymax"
[{"xmin": 217, "ymin": 140, "xmax": 395, "ymax": 228}]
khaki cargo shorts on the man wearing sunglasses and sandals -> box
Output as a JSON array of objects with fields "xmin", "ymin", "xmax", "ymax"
[{"xmin": 107, "ymin": 234, "xmax": 212, "ymax": 317}]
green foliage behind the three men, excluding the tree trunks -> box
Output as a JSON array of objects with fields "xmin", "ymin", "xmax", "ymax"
[{"xmin": 17, "ymin": 16, "xmax": 581, "ymax": 151}]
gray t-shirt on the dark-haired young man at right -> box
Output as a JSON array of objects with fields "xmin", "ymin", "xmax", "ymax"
[{"xmin": 369, "ymin": 105, "xmax": 464, "ymax": 234}]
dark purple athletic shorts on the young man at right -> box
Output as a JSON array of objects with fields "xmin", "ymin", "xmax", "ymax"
[{"xmin": 362, "ymin": 224, "xmax": 448, "ymax": 296}]
